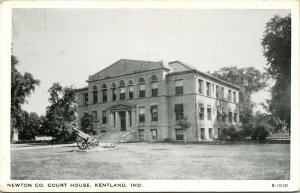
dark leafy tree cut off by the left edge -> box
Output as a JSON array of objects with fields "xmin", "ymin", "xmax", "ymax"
[{"xmin": 10, "ymin": 55, "xmax": 40, "ymax": 141}]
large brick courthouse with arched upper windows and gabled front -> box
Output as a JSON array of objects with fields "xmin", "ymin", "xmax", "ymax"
[{"xmin": 77, "ymin": 59, "xmax": 239, "ymax": 141}]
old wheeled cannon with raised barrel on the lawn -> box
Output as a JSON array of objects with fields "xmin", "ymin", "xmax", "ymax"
[{"xmin": 72, "ymin": 125, "xmax": 99, "ymax": 149}]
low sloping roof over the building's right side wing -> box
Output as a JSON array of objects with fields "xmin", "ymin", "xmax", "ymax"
[{"xmin": 167, "ymin": 60, "xmax": 240, "ymax": 90}]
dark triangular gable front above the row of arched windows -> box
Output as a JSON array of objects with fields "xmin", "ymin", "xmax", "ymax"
[{"xmin": 88, "ymin": 59, "xmax": 169, "ymax": 82}]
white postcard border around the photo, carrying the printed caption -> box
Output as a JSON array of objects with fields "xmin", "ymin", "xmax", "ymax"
[{"xmin": 0, "ymin": 0, "xmax": 300, "ymax": 192}]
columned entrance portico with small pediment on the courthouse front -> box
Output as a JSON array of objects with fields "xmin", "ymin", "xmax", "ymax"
[{"xmin": 109, "ymin": 103, "xmax": 135, "ymax": 131}]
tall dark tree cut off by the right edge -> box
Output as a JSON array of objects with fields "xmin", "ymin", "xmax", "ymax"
[{"xmin": 261, "ymin": 15, "xmax": 291, "ymax": 133}]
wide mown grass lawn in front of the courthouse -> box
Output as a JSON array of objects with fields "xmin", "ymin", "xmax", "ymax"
[{"xmin": 11, "ymin": 143, "xmax": 290, "ymax": 180}]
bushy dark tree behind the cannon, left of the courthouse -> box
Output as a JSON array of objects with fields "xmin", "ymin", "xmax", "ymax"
[{"xmin": 43, "ymin": 83, "xmax": 77, "ymax": 141}]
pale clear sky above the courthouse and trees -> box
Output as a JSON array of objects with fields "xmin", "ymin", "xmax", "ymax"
[{"xmin": 12, "ymin": 9, "xmax": 290, "ymax": 115}]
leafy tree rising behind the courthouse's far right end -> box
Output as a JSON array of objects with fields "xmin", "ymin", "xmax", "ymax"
[{"xmin": 212, "ymin": 66, "xmax": 266, "ymax": 123}]
